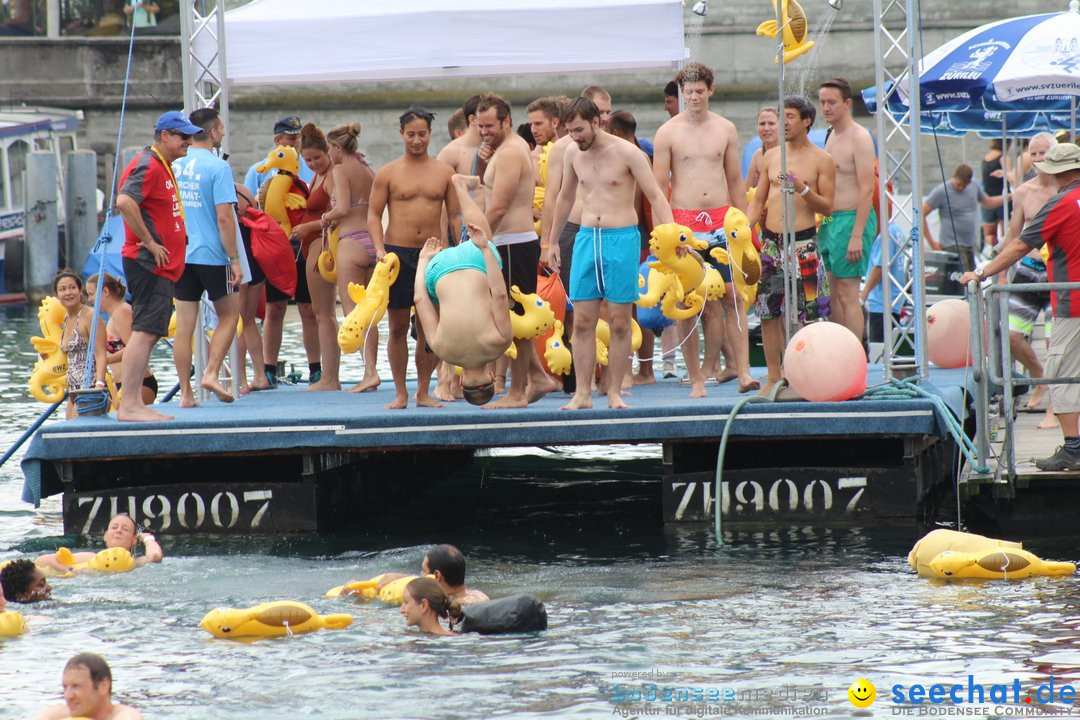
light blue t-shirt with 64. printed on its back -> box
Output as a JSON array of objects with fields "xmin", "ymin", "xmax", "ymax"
[{"xmin": 173, "ymin": 148, "xmax": 237, "ymax": 264}]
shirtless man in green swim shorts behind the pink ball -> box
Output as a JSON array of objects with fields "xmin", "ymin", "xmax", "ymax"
[{"xmin": 818, "ymin": 78, "xmax": 878, "ymax": 339}]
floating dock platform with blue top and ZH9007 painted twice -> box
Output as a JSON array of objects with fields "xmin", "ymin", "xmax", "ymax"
[{"xmin": 23, "ymin": 366, "xmax": 969, "ymax": 534}]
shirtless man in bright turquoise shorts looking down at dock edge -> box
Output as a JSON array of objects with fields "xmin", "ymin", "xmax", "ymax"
[{"xmin": 549, "ymin": 97, "xmax": 673, "ymax": 410}]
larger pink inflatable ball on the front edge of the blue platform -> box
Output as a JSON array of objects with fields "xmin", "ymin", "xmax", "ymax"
[{"xmin": 784, "ymin": 323, "xmax": 866, "ymax": 403}]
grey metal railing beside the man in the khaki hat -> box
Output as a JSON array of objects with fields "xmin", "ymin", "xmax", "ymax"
[{"xmin": 967, "ymin": 282, "xmax": 1080, "ymax": 483}]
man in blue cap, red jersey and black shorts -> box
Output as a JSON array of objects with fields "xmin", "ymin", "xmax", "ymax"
[{"xmin": 117, "ymin": 110, "xmax": 202, "ymax": 422}]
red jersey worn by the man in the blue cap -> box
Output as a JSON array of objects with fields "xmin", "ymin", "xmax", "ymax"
[{"xmin": 120, "ymin": 148, "xmax": 188, "ymax": 283}]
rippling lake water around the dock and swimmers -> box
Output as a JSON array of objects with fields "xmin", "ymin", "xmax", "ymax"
[{"xmin": 0, "ymin": 309, "xmax": 1080, "ymax": 720}]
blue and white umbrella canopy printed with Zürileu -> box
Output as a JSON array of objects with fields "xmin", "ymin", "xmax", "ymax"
[{"xmin": 899, "ymin": 0, "xmax": 1080, "ymax": 111}]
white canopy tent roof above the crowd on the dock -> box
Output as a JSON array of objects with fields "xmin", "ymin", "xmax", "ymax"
[{"xmin": 217, "ymin": 0, "xmax": 686, "ymax": 85}]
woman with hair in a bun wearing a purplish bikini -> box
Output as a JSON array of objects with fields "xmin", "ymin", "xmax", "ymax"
[{"xmin": 322, "ymin": 123, "xmax": 379, "ymax": 393}]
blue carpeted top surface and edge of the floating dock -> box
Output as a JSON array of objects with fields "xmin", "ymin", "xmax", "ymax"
[{"xmin": 23, "ymin": 366, "xmax": 971, "ymax": 504}]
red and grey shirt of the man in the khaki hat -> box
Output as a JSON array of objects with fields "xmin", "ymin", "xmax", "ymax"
[{"xmin": 1020, "ymin": 180, "xmax": 1080, "ymax": 317}]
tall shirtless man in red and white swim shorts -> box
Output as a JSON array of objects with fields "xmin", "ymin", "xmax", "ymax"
[{"xmin": 652, "ymin": 63, "xmax": 759, "ymax": 397}]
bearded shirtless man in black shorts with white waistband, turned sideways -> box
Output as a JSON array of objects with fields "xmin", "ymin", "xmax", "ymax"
[{"xmin": 476, "ymin": 95, "xmax": 555, "ymax": 409}]
